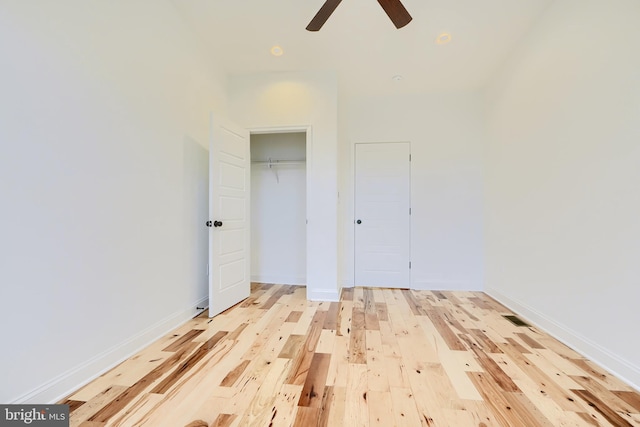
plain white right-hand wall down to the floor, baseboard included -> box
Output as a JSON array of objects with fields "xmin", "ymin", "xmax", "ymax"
[{"xmin": 485, "ymin": 0, "xmax": 640, "ymax": 387}]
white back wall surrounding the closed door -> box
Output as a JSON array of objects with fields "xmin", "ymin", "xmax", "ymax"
[{"xmin": 340, "ymin": 94, "xmax": 484, "ymax": 290}]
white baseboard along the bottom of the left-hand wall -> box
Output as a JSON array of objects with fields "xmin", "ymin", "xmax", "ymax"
[{"xmin": 9, "ymin": 297, "xmax": 209, "ymax": 404}]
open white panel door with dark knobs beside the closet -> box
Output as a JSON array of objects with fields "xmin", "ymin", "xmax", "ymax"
[{"xmin": 207, "ymin": 116, "xmax": 251, "ymax": 317}]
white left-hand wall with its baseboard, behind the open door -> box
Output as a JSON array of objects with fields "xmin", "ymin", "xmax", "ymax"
[{"xmin": 0, "ymin": 0, "xmax": 225, "ymax": 403}]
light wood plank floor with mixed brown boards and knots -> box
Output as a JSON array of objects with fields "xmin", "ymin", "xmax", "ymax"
[{"xmin": 61, "ymin": 284, "xmax": 640, "ymax": 427}]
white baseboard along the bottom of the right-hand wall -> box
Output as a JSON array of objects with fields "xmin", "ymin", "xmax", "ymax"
[{"xmin": 485, "ymin": 289, "xmax": 640, "ymax": 391}]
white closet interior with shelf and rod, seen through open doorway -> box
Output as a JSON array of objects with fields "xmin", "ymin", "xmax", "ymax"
[{"xmin": 251, "ymin": 133, "xmax": 307, "ymax": 285}]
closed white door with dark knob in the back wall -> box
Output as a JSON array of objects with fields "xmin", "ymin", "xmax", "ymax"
[{"xmin": 355, "ymin": 142, "xmax": 411, "ymax": 288}]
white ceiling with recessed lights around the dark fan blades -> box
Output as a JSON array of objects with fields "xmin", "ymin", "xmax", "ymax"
[{"xmin": 173, "ymin": 0, "xmax": 554, "ymax": 95}]
